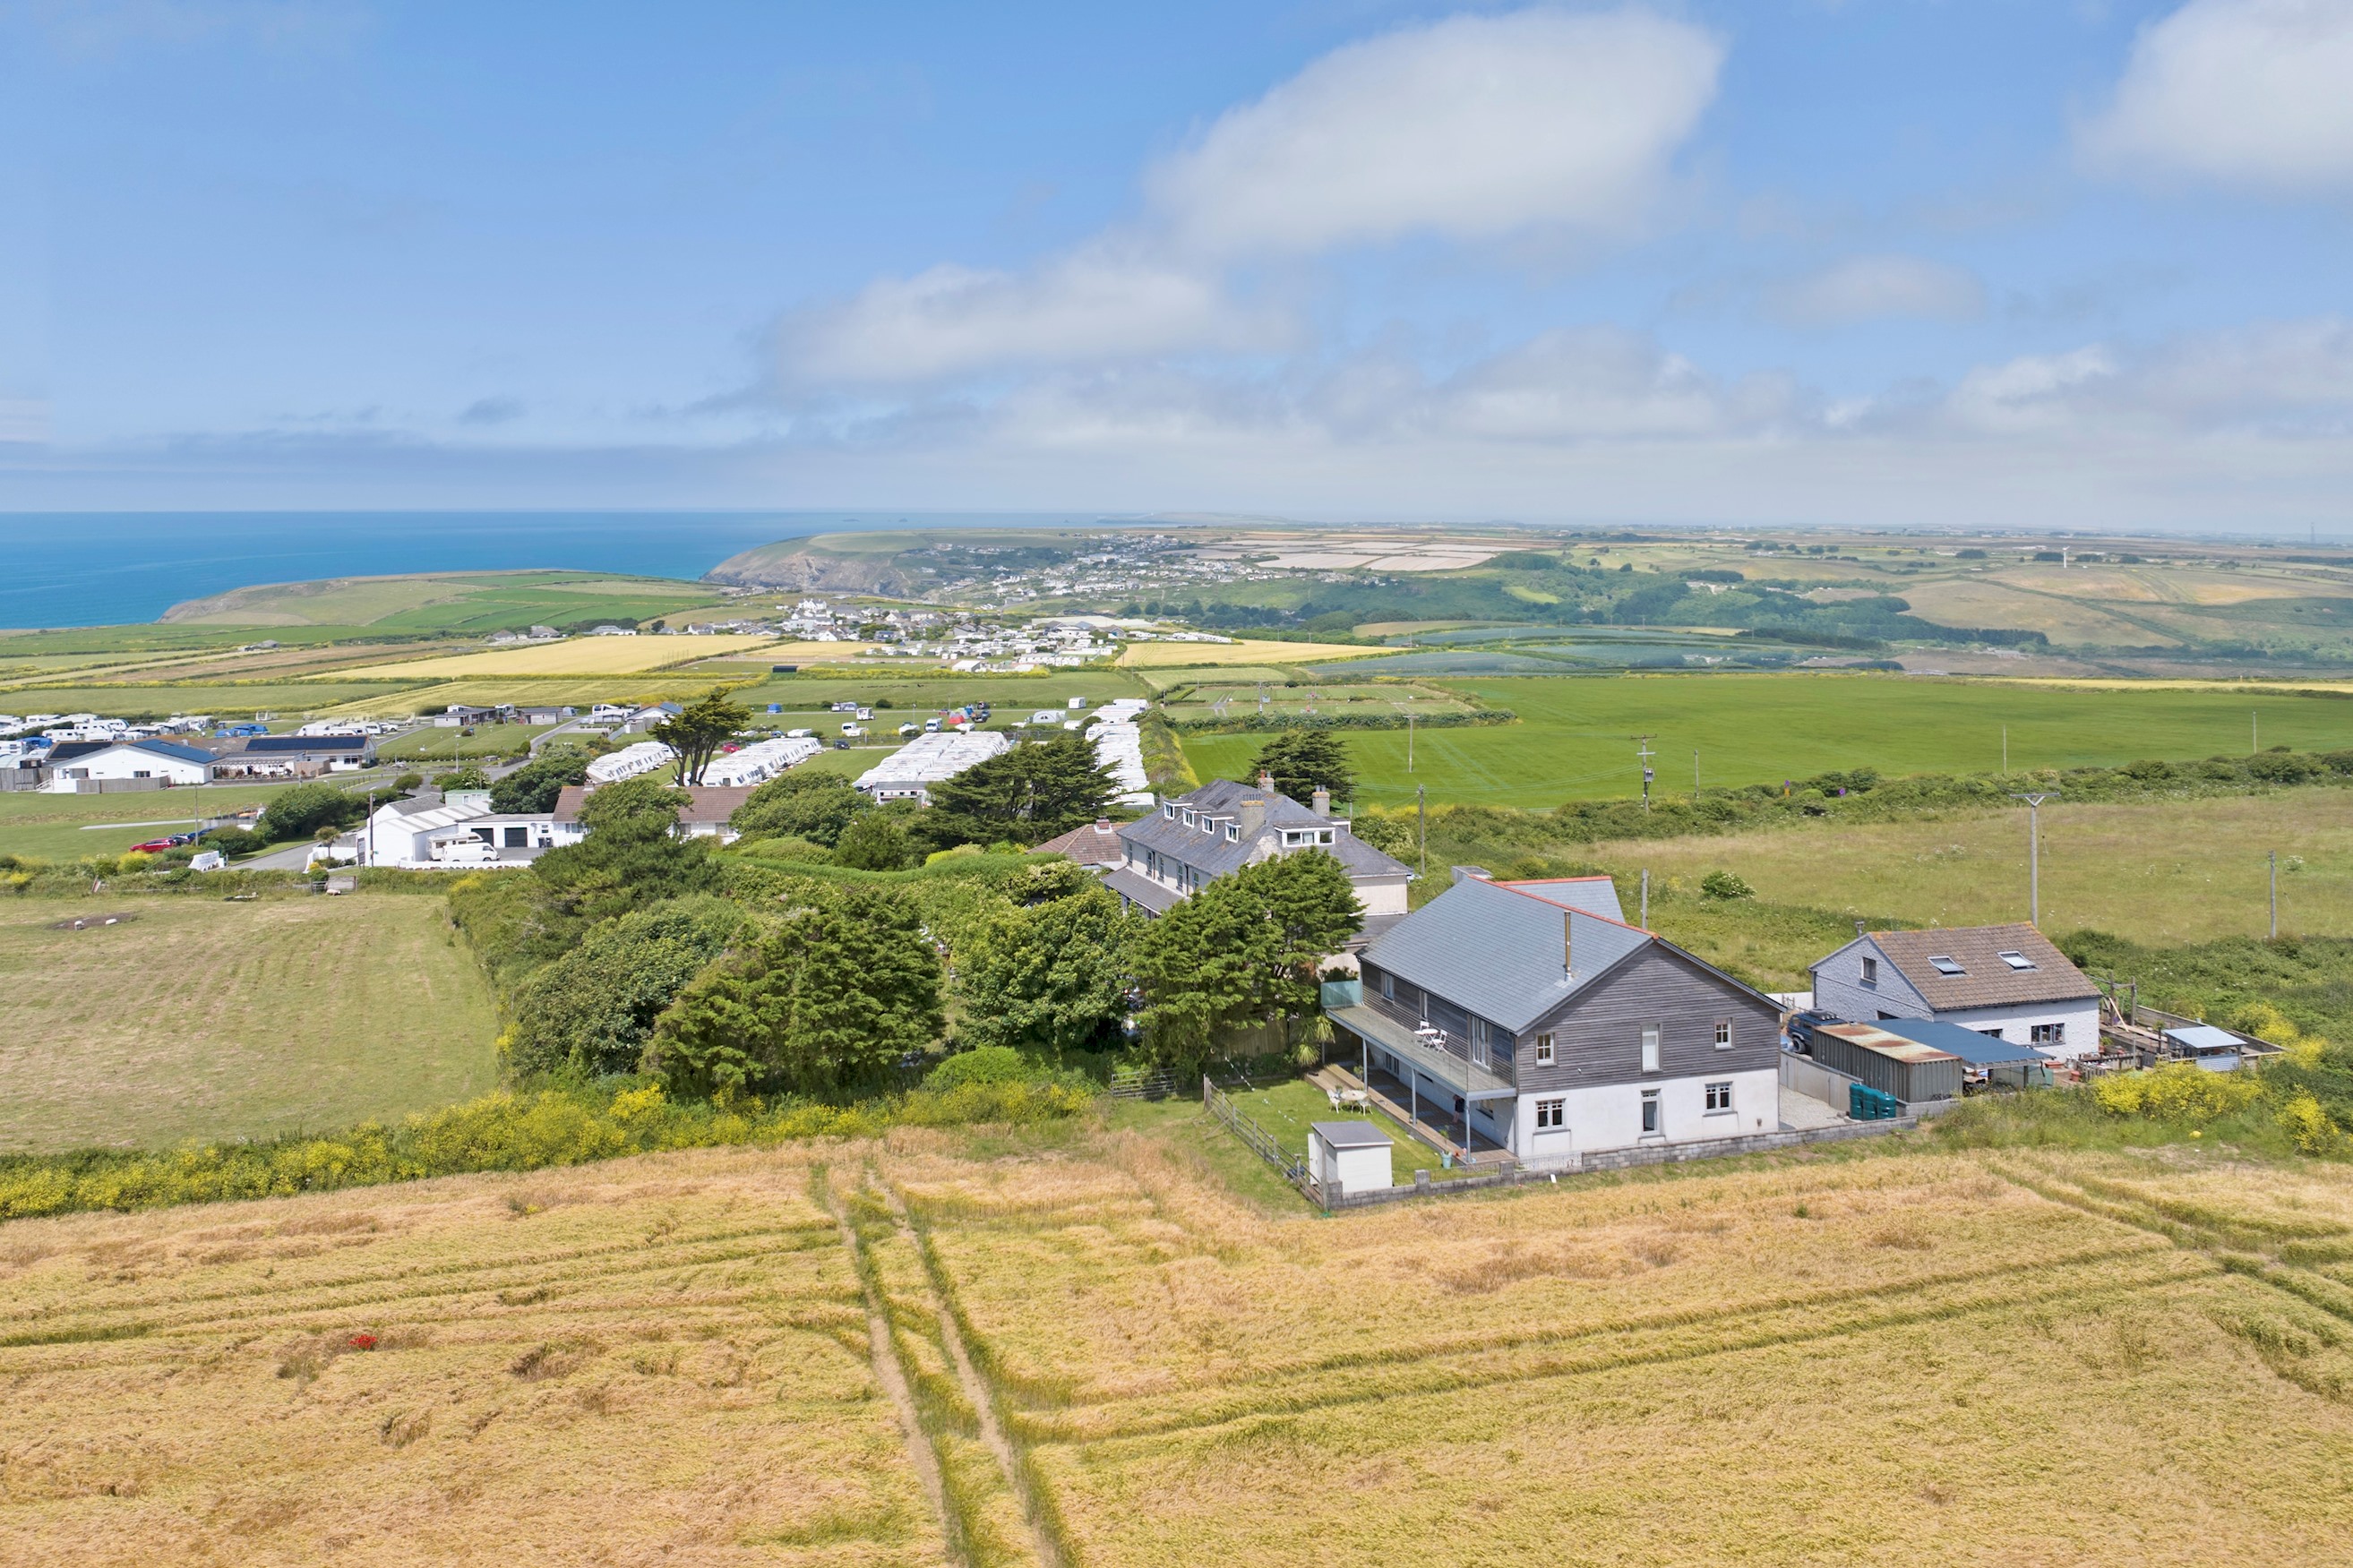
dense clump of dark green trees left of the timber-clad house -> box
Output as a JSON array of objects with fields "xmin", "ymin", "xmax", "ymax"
[{"xmin": 451, "ymin": 733, "xmax": 1362, "ymax": 1105}]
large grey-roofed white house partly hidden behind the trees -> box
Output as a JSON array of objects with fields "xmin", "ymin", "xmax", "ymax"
[{"xmin": 1104, "ymin": 778, "xmax": 1414, "ymax": 940}]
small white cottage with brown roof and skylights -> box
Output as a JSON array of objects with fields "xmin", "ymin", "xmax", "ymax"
[{"xmin": 1814, "ymin": 924, "xmax": 2099, "ymax": 1058}]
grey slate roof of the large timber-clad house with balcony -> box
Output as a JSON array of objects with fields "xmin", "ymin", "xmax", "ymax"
[{"xmin": 1365, "ymin": 877, "xmax": 1656, "ymax": 1032}]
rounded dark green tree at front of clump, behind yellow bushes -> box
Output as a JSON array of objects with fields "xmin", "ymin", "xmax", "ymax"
[{"xmin": 640, "ymin": 888, "xmax": 941, "ymax": 1105}]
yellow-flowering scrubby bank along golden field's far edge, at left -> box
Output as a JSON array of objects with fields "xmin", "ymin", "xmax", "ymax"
[{"xmin": 0, "ymin": 1076, "xmax": 1092, "ymax": 1220}]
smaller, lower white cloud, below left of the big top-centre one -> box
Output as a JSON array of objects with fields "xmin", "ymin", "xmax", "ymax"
[{"xmin": 784, "ymin": 247, "xmax": 1280, "ymax": 386}]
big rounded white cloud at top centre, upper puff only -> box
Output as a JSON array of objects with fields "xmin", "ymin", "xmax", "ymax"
[{"xmin": 1146, "ymin": 10, "xmax": 1725, "ymax": 256}]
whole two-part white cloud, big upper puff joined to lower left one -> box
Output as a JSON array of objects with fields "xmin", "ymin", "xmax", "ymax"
[{"xmin": 779, "ymin": 10, "xmax": 1725, "ymax": 386}]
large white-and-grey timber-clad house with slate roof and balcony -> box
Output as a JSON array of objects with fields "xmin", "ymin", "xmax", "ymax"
[{"xmin": 1329, "ymin": 870, "xmax": 1782, "ymax": 1163}]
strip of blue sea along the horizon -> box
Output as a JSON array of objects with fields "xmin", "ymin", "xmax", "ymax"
[{"xmin": 0, "ymin": 510, "xmax": 1106, "ymax": 628}]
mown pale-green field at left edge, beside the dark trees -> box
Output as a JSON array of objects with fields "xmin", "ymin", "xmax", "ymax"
[{"xmin": 0, "ymin": 893, "xmax": 499, "ymax": 1152}]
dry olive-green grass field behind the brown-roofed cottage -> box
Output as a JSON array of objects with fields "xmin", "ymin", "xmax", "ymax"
[{"xmin": 1576, "ymin": 790, "xmax": 2353, "ymax": 978}]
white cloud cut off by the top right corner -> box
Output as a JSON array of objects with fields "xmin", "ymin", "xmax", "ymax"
[{"xmin": 2080, "ymin": 0, "xmax": 2353, "ymax": 193}]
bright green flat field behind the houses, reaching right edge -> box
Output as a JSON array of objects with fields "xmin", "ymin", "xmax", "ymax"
[{"xmin": 1183, "ymin": 674, "xmax": 2353, "ymax": 806}]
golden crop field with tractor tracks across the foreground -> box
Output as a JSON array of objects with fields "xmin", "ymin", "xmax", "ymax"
[{"xmin": 13, "ymin": 1131, "xmax": 2353, "ymax": 1568}]
